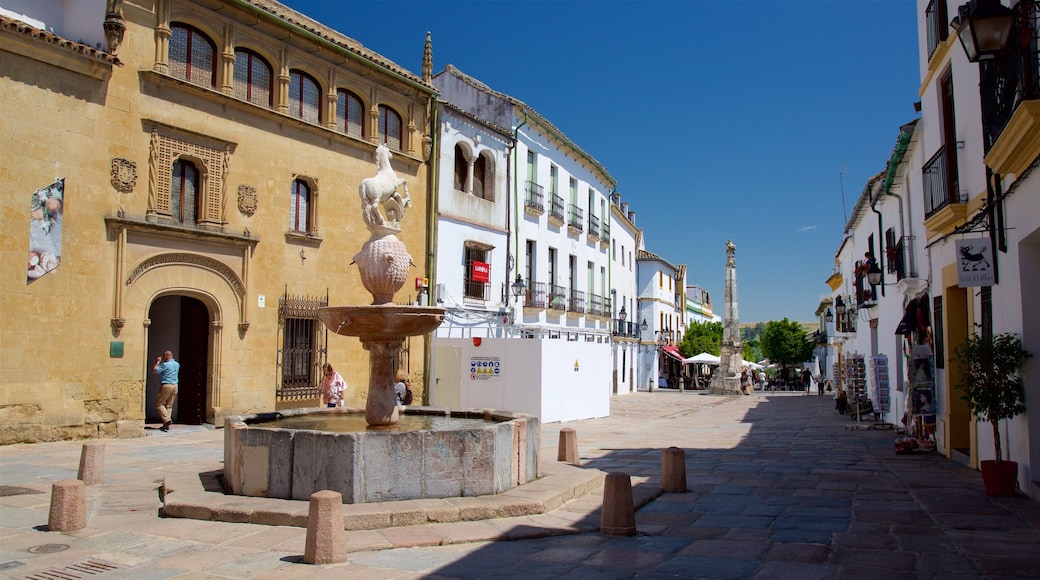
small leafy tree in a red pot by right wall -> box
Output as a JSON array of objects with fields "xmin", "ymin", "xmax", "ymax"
[{"xmin": 954, "ymin": 333, "xmax": 1032, "ymax": 496}]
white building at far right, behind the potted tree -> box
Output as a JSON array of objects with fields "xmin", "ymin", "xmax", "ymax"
[{"xmin": 911, "ymin": 0, "xmax": 1040, "ymax": 498}]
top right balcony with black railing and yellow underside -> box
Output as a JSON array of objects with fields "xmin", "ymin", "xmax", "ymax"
[{"xmin": 979, "ymin": 0, "xmax": 1040, "ymax": 175}]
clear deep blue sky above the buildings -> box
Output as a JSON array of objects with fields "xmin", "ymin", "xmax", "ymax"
[{"xmin": 282, "ymin": 0, "xmax": 920, "ymax": 322}]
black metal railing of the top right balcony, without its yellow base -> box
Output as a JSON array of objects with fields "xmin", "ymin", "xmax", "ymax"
[{"xmin": 979, "ymin": 0, "xmax": 1040, "ymax": 153}]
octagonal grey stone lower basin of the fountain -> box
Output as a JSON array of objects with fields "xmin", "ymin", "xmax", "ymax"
[{"xmin": 224, "ymin": 407, "xmax": 540, "ymax": 503}]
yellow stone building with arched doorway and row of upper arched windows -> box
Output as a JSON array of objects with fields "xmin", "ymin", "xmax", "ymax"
[{"xmin": 0, "ymin": 0, "xmax": 436, "ymax": 444}]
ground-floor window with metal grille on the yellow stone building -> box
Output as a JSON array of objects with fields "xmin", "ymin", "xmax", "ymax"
[{"xmin": 275, "ymin": 291, "xmax": 329, "ymax": 401}]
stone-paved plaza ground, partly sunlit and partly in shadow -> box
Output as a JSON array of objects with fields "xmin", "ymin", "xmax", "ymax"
[{"xmin": 0, "ymin": 392, "xmax": 1040, "ymax": 580}]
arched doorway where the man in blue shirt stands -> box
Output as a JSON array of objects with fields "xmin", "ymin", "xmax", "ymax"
[{"xmin": 145, "ymin": 296, "xmax": 210, "ymax": 425}]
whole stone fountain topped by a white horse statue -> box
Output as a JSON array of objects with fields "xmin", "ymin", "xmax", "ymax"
[{"xmin": 224, "ymin": 146, "xmax": 541, "ymax": 503}]
